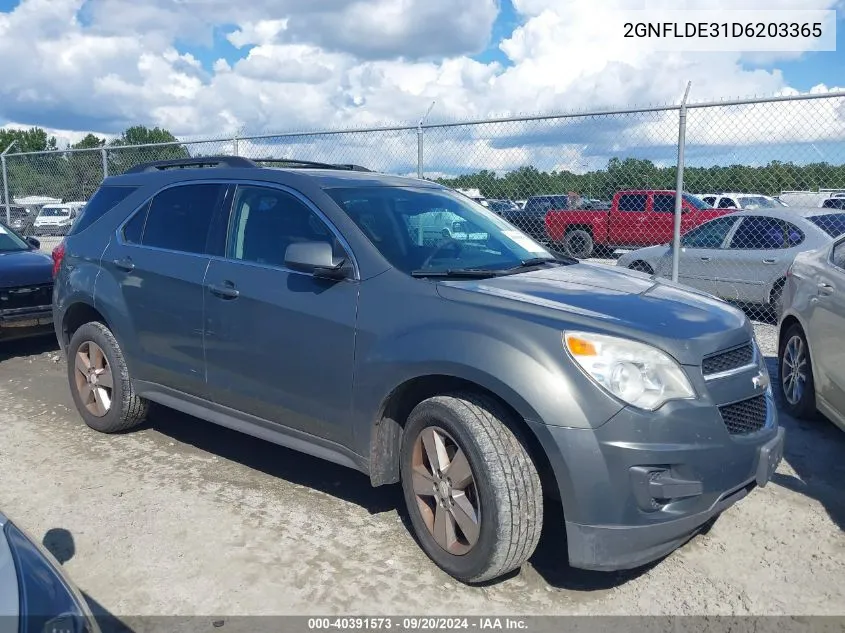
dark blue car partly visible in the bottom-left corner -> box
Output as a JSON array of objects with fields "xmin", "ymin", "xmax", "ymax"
[{"xmin": 0, "ymin": 513, "xmax": 100, "ymax": 633}]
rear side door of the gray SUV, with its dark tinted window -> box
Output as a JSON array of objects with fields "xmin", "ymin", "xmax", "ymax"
[{"xmin": 102, "ymin": 183, "xmax": 227, "ymax": 397}]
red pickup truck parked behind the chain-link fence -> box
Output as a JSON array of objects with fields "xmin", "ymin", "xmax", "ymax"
[{"xmin": 545, "ymin": 190, "xmax": 732, "ymax": 259}]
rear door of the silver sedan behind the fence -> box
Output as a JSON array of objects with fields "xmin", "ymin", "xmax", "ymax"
[{"xmin": 718, "ymin": 215, "xmax": 791, "ymax": 304}]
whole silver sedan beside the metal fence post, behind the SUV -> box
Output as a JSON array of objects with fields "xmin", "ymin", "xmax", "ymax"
[{"xmin": 616, "ymin": 208, "xmax": 845, "ymax": 311}]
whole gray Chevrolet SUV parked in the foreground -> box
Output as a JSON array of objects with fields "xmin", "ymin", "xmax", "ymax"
[{"xmin": 54, "ymin": 157, "xmax": 783, "ymax": 582}]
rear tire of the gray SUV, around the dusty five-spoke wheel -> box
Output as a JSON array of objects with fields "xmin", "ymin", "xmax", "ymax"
[{"xmin": 67, "ymin": 322, "xmax": 149, "ymax": 433}]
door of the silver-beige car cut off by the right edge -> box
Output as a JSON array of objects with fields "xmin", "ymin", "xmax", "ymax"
[{"xmin": 807, "ymin": 239, "xmax": 845, "ymax": 419}]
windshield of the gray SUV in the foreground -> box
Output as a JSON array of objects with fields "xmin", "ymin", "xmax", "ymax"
[{"xmin": 326, "ymin": 187, "xmax": 556, "ymax": 274}]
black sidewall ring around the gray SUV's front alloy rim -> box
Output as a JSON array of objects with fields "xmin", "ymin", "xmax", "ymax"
[{"xmin": 400, "ymin": 399, "xmax": 499, "ymax": 582}]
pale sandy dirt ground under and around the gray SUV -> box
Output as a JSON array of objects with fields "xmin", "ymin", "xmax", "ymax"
[{"xmin": 0, "ymin": 330, "xmax": 845, "ymax": 617}]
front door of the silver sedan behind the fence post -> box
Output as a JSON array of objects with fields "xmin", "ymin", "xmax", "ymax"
[{"xmin": 658, "ymin": 216, "xmax": 737, "ymax": 296}]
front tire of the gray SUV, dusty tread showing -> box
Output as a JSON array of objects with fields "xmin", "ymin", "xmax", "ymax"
[{"xmin": 400, "ymin": 393, "xmax": 543, "ymax": 583}]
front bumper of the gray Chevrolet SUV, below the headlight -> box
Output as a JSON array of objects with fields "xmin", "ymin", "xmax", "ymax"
[{"xmin": 531, "ymin": 393, "xmax": 784, "ymax": 571}]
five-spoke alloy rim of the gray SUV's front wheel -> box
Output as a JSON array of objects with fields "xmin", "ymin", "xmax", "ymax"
[{"xmin": 411, "ymin": 426, "xmax": 481, "ymax": 556}]
